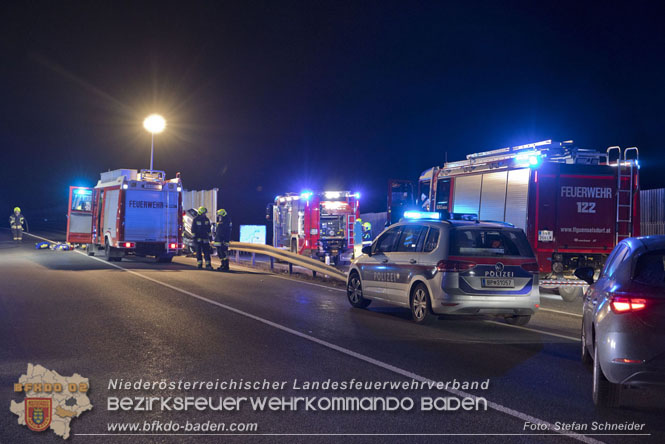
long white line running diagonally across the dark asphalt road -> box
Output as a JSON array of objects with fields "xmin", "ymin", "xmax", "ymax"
[{"xmin": 22, "ymin": 235, "xmax": 601, "ymax": 444}]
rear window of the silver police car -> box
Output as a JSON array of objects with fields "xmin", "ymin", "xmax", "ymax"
[{"xmin": 450, "ymin": 228, "xmax": 533, "ymax": 257}]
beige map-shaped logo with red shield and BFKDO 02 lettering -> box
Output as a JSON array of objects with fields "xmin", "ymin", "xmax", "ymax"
[{"xmin": 9, "ymin": 364, "xmax": 92, "ymax": 439}]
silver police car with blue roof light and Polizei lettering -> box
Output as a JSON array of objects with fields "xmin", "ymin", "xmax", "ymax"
[{"xmin": 347, "ymin": 211, "xmax": 540, "ymax": 325}]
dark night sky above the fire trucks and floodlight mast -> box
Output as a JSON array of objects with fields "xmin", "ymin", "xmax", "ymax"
[{"xmin": 0, "ymin": 0, "xmax": 665, "ymax": 224}]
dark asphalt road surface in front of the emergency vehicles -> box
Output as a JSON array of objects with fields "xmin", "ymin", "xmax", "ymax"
[{"xmin": 0, "ymin": 231, "xmax": 665, "ymax": 443}]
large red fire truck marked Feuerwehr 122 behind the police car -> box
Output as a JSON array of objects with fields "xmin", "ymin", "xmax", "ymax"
[{"xmin": 388, "ymin": 140, "xmax": 640, "ymax": 301}]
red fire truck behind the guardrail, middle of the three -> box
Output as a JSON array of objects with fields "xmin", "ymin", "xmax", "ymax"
[{"xmin": 267, "ymin": 191, "xmax": 360, "ymax": 264}]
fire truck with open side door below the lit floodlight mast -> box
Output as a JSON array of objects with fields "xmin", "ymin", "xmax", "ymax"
[{"xmin": 67, "ymin": 169, "xmax": 182, "ymax": 262}]
